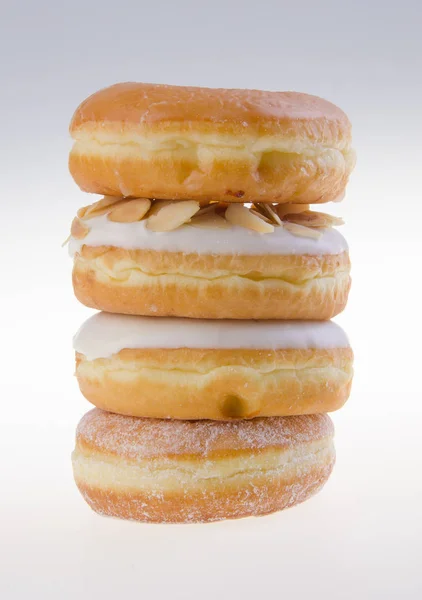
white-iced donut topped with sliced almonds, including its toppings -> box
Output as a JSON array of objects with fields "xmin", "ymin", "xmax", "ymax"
[{"xmin": 69, "ymin": 197, "xmax": 350, "ymax": 320}]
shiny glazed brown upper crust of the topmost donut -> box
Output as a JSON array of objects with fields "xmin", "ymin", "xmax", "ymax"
[{"xmin": 70, "ymin": 82, "xmax": 351, "ymax": 137}]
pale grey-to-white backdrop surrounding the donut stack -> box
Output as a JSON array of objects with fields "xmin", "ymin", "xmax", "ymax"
[{"xmin": 0, "ymin": 0, "xmax": 422, "ymax": 600}]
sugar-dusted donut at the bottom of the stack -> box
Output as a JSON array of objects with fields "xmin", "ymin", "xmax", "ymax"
[{"xmin": 72, "ymin": 409, "xmax": 335, "ymax": 523}]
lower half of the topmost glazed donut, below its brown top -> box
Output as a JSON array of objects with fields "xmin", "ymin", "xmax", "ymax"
[{"xmin": 69, "ymin": 140, "xmax": 355, "ymax": 204}]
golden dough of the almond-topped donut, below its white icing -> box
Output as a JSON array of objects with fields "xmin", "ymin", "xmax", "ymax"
[{"xmin": 73, "ymin": 246, "xmax": 350, "ymax": 320}]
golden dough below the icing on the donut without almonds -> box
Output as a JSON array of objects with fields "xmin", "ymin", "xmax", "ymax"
[{"xmin": 76, "ymin": 348, "xmax": 353, "ymax": 420}]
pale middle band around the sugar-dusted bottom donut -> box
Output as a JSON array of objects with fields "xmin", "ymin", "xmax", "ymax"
[{"xmin": 72, "ymin": 438, "xmax": 334, "ymax": 492}]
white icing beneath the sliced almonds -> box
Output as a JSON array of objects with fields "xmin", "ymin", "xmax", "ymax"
[{"xmin": 69, "ymin": 215, "xmax": 348, "ymax": 256}]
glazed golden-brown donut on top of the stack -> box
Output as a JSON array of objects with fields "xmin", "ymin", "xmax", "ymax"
[{"xmin": 69, "ymin": 83, "xmax": 355, "ymax": 204}]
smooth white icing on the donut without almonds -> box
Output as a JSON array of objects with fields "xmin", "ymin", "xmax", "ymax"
[{"xmin": 73, "ymin": 313, "xmax": 349, "ymax": 360}]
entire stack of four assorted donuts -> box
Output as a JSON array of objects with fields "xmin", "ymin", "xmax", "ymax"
[{"xmin": 69, "ymin": 83, "xmax": 355, "ymax": 523}]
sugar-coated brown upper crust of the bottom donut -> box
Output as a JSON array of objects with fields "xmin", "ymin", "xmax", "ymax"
[{"xmin": 76, "ymin": 408, "xmax": 334, "ymax": 460}]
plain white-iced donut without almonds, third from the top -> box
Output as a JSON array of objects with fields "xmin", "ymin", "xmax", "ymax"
[{"xmin": 74, "ymin": 313, "xmax": 353, "ymax": 420}]
